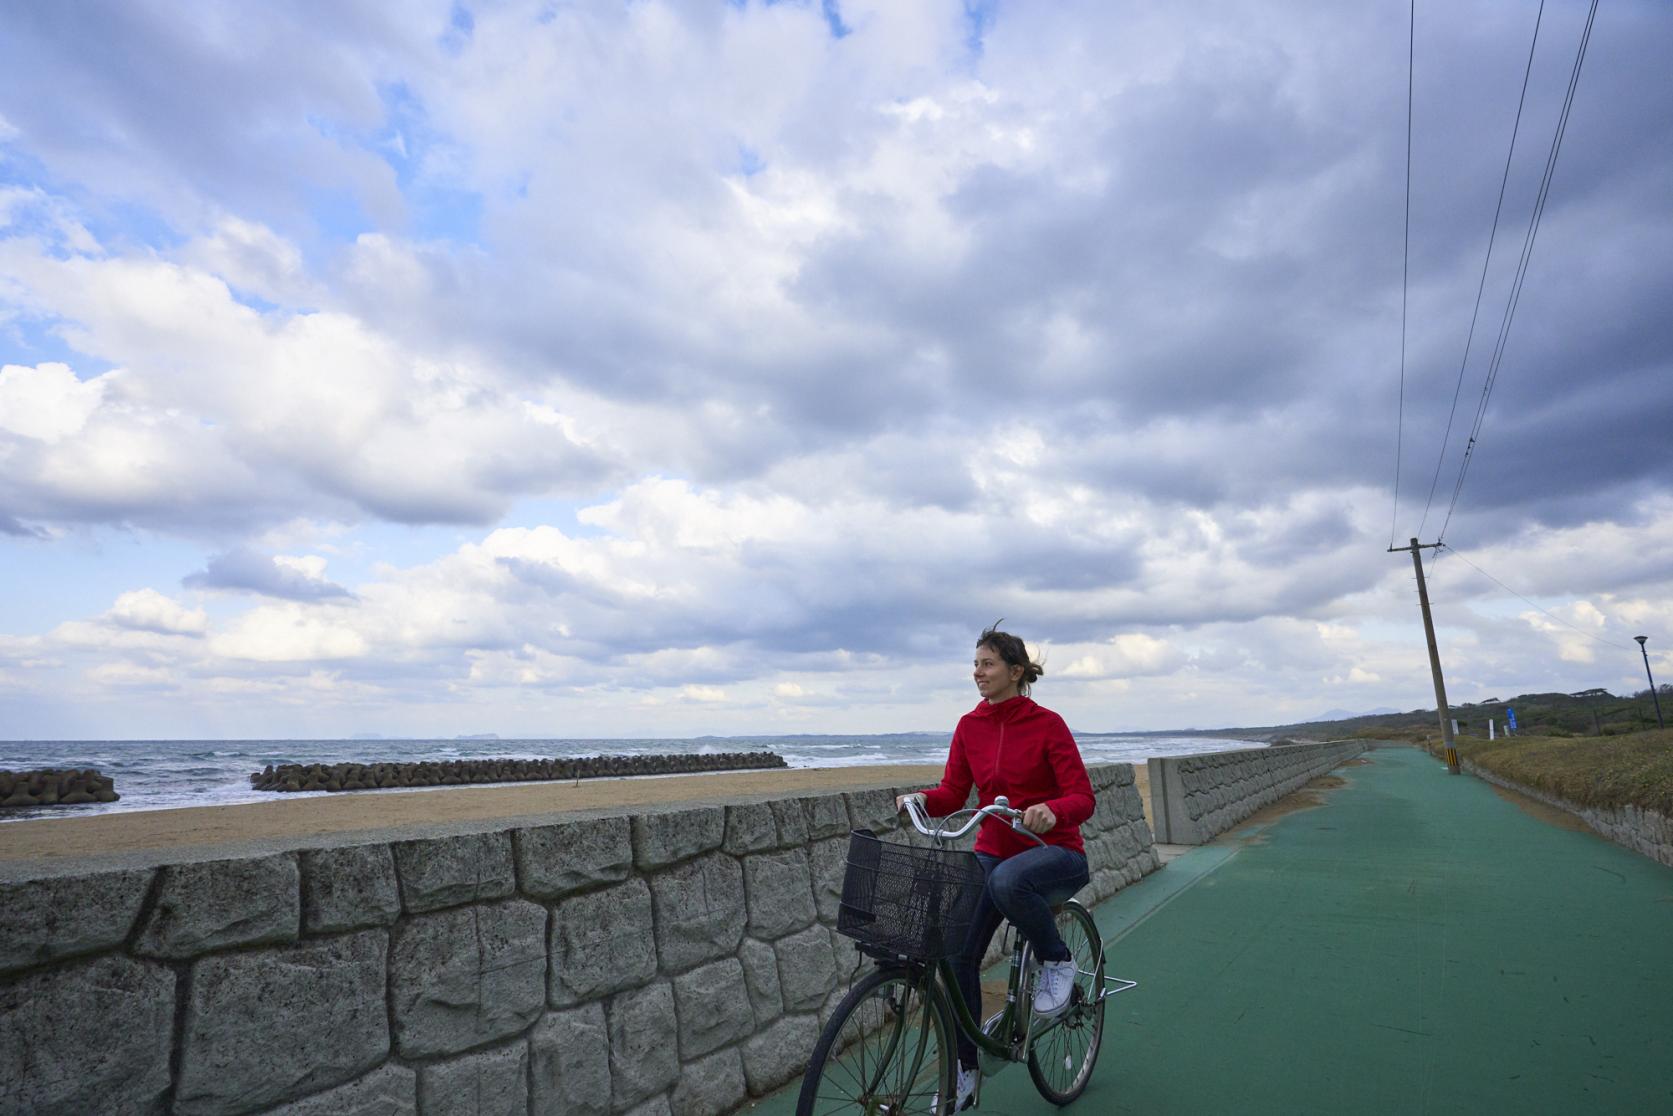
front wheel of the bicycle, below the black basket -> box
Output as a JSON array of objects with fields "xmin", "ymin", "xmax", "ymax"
[{"xmin": 796, "ymin": 969, "xmax": 957, "ymax": 1116}]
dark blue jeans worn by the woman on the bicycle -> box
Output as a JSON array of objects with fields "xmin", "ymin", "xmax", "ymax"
[{"xmin": 952, "ymin": 845, "xmax": 1091, "ymax": 1066}]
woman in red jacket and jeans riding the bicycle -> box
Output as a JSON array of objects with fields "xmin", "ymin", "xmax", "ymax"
[{"xmin": 895, "ymin": 624, "xmax": 1096, "ymax": 1111}]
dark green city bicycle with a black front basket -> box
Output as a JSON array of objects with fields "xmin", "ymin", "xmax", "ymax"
[{"xmin": 796, "ymin": 796, "xmax": 1138, "ymax": 1116}]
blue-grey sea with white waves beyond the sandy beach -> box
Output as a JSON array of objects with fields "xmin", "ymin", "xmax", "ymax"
[{"xmin": 0, "ymin": 733, "xmax": 1261, "ymax": 823}]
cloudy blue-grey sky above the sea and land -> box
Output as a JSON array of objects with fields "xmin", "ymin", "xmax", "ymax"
[{"xmin": 0, "ymin": 0, "xmax": 1673, "ymax": 738}]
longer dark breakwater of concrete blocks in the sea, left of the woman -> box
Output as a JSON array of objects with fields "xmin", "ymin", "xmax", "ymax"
[{"xmin": 249, "ymin": 751, "xmax": 786, "ymax": 791}]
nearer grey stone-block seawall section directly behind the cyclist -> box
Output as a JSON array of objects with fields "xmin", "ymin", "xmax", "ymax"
[{"xmin": 0, "ymin": 765, "xmax": 1158, "ymax": 1116}]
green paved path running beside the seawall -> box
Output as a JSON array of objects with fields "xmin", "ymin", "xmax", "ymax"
[{"xmin": 755, "ymin": 748, "xmax": 1673, "ymax": 1114}]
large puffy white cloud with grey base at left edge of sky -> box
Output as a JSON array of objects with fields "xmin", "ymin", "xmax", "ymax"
[{"xmin": 0, "ymin": 230, "xmax": 604, "ymax": 525}]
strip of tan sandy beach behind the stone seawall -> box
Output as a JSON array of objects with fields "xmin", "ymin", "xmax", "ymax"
[{"xmin": 0, "ymin": 765, "xmax": 1149, "ymax": 868}]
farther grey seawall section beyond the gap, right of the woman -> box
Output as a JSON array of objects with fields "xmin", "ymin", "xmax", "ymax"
[{"xmin": 1149, "ymin": 741, "xmax": 1365, "ymax": 845}]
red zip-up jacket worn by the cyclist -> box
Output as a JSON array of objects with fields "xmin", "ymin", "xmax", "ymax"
[{"xmin": 923, "ymin": 696, "xmax": 1097, "ymax": 858}]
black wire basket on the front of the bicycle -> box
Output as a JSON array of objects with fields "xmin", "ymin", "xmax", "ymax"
[{"xmin": 837, "ymin": 830, "xmax": 987, "ymax": 960}]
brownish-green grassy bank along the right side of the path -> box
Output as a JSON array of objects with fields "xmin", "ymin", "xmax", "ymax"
[{"xmin": 1457, "ymin": 729, "xmax": 1673, "ymax": 817}]
